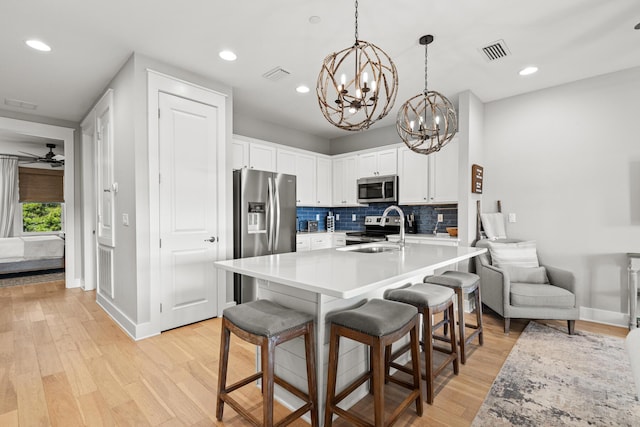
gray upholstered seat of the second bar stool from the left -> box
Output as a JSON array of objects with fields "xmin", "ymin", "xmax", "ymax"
[{"xmin": 327, "ymin": 299, "xmax": 418, "ymax": 337}]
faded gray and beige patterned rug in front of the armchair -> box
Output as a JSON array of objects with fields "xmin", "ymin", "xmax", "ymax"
[{"xmin": 472, "ymin": 322, "xmax": 640, "ymax": 427}]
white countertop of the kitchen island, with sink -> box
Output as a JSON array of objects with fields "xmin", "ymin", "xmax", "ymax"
[{"xmin": 214, "ymin": 243, "xmax": 486, "ymax": 298}]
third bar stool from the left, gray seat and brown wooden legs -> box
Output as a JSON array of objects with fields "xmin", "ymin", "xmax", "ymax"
[{"xmin": 384, "ymin": 283, "xmax": 460, "ymax": 404}]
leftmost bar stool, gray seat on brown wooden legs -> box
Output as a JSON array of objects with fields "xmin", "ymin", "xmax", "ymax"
[{"xmin": 216, "ymin": 300, "xmax": 318, "ymax": 427}]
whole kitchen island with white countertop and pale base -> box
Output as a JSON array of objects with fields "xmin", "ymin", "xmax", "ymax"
[{"xmin": 214, "ymin": 243, "xmax": 486, "ymax": 426}]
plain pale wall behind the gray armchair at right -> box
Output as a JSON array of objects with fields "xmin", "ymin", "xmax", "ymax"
[{"xmin": 483, "ymin": 68, "xmax": 640, "ymax": 324}]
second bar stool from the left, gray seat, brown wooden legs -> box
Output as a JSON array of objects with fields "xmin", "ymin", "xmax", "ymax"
[{"xmin": 324, "ymin": 299, "xmax": 423, "ymax": 427}]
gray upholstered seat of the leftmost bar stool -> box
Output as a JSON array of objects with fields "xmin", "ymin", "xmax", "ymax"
[{"xmin": 222, "ymin": 300, "xmax": 314, "ymax": 337}]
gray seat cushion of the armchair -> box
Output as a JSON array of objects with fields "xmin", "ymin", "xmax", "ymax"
[{"xmin": 511, "ymin": 283, "xmax": 576, "ymax": 308}]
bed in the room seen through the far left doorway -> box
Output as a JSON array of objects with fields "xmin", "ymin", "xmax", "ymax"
[{"xmin": 0, "ymin": 236, "xmax": 64, "ymax": 274}]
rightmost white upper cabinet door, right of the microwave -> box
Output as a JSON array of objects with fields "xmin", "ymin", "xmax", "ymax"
[{"xmin": 430, "ymin": 138, "xmax": 458, "ymax": 203}]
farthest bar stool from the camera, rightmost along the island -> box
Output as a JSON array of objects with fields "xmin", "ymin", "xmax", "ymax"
[{"xmin": 424, "ymin": 271, "xmax": 484, "ymax": 364}]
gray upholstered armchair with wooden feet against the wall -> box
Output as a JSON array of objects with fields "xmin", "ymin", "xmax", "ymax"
[{"xmin": 475, "ymin": 239, "xmax": 579, "ymax": 335}]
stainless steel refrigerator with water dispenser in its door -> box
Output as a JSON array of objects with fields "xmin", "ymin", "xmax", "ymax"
[{"xmin": 233, "ymin": 169, "xmax": 296, "ymax": 304}]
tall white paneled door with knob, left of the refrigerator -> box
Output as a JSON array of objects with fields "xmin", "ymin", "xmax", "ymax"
[{"xmin": 159, "ymin": 92, "xmax": 224, "ymax": 330}]
